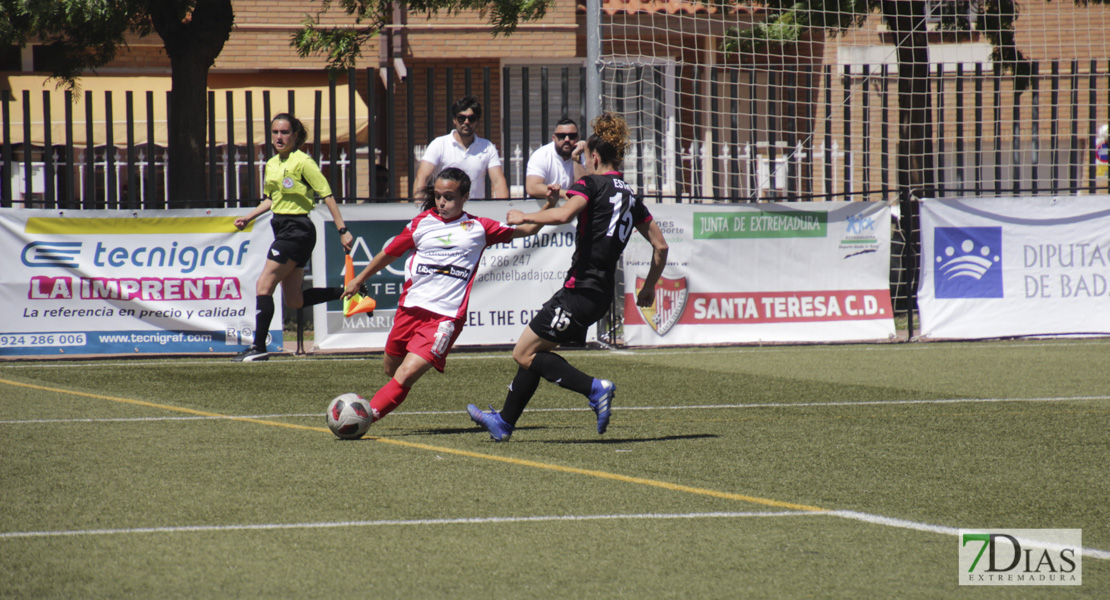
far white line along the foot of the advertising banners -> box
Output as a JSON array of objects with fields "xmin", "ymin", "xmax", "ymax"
[{"xmin": 0, "ymin": 337, "xmax": 1110, "ymax": 369}]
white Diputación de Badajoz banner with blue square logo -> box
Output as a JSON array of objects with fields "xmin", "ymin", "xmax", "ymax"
[{"xmin": 918, "ymin": 196, "xmax": 1110, "ymax": 338}]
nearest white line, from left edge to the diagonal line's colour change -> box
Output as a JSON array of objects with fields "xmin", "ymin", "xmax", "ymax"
[{"xmin": 0, "ymin": 510, "xmax": 821, "ymax": 539}]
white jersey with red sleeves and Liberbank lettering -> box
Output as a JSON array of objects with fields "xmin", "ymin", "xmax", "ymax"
[{"xmin": 385, "ymin": 210, "xmax": 516, "ymax": 318}]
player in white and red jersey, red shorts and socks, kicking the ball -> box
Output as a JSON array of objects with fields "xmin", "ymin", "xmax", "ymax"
[{"xmin": 343, "ymin": 167, "xmax": 558, "ymax": 420}]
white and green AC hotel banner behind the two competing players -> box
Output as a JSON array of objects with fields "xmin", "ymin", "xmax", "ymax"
[{"xmin": 312, "ymin": 200, "xmax": 577, "ymax": 349}]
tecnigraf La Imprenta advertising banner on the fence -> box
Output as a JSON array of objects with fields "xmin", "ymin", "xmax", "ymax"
[{"xmin": 0, "ymin": 209, "xmax": 282, "ymax": 356}]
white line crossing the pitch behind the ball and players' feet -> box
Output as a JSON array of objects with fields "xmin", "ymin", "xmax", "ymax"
[{"xmin": 0, "ymin": 396, "xmax": 1110, "ymax": 425}]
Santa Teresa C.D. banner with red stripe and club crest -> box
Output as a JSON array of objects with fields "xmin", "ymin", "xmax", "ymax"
[{"xmin": 624, "ymin": 202, "xmax": 895, "ymax": 346}]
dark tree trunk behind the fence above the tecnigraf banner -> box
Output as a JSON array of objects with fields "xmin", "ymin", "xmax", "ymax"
[{"xmin": 150, "ymin": 0, "xmax": 234, "ymax": 209}]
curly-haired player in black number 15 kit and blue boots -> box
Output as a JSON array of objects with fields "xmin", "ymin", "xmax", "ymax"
[{"xmin": 466, "ymin": 113, "xmax": 667, "ymax": 441}]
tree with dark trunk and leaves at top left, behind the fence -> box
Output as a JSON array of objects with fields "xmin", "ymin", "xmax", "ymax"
[{"xmin": 0, "ymin": 0, "xmax": 234, "ymax": 206}]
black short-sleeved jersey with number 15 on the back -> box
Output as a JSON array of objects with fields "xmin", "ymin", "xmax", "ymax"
[{"xmin": 563, "ymin": 172, "xmax": 652, "ymax": 293}]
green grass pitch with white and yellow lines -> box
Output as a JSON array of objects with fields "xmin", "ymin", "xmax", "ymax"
[{"xmin": 0, "ymin": 339, "xmax": 1110, "ymax": 599}]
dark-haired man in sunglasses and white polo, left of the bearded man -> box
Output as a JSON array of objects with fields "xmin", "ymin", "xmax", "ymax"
[{"xmin": 414, "ymin": 95, "xmax": 508, "ymax": 200}]
